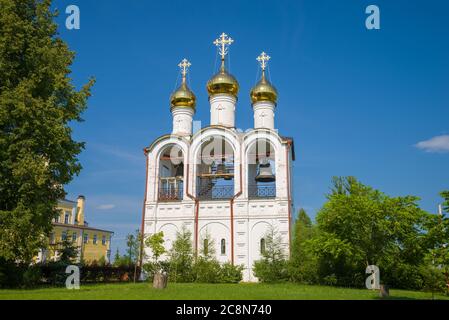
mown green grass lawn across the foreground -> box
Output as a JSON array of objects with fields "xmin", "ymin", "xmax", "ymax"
[{"xmin": 0, "ymin": 283, "xmax": 449, "ymax": 300}]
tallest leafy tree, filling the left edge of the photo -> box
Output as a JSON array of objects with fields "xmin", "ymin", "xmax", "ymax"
[{"xmin": 0, "ymin": 0, "xmax": 94, "ymax": 262}]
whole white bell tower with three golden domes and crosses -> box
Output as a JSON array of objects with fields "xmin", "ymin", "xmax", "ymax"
[{"xmin": 142, "ymin": 33, "xmax": 295, "ymax": 281}]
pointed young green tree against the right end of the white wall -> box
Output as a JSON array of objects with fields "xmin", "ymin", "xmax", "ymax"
[{"xmin": 253, "ymin": 226, "xmax": 288, "ymax": 282}]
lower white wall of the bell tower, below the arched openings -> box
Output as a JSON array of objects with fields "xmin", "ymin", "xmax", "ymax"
[{"xmin": 145, "ymin": 200, "xmax": 289, "ymax": 282}]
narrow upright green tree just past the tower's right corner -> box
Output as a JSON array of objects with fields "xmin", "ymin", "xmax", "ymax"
[{"xmin": 289, "ymin": 209, "xmax": 317, "ymax": 283}]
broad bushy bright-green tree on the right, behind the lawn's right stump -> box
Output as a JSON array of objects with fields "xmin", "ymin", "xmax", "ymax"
[{"xmin": 311, "ymin": 177, "xmax": 428, "ymax": 288}]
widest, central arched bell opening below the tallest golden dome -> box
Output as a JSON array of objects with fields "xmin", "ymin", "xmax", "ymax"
[{"xmin": 196, "ymin": 136, "xmax": 234, "ymax": 200}]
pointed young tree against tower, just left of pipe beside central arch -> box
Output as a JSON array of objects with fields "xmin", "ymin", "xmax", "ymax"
[{"xmin": 169, "ymin": 227, "xmax": 193, "ymax": 282}]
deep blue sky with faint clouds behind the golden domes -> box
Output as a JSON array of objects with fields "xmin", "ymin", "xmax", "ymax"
[{"xmin": 55, "ymin": 0, "xmax": 449, "ymax": 253}]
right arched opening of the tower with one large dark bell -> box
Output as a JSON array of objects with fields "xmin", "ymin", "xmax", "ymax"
[{"xmin": 247, "ymin": 139, "xmax": 276, "ymax": 199}]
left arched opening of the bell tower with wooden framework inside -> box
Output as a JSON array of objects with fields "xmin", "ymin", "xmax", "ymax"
[{"xmin": 158, "ymin": 145, "xmax": 184, "ymax": 201}]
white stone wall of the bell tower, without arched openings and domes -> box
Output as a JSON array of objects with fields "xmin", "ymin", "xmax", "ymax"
[{"xmin": 144, "ymin": 127, "xmax": 291, "ymax": 281}]
